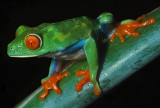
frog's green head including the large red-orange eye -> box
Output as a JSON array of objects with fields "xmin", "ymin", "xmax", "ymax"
[{"xmin": 7, "ymin": 25, "xmax": 49, "ymax": 57}]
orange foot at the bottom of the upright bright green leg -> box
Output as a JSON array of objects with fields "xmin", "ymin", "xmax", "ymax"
[{"xmin": 76, "ymin": 69, "xmax": 101, "ymax": 95}]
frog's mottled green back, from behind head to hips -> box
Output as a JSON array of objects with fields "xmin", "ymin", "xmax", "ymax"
[{"xmin": 39, "ymin": 16, "xmax": 96, "ymax": 51}]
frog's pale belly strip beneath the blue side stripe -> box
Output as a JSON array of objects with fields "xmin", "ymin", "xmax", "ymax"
[{"xmin": 54, "ymin": 49, "xmax": 86, "ymax": 60}]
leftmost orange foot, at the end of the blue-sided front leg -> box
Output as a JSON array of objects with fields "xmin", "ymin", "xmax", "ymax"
[{"xmin": 39, "ymin": 70, "xmax": 69, "ymax": 100}]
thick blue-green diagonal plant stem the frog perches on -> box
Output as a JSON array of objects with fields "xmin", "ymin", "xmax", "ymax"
[{"xmin": 16, "ymin": 8, "xmax": 160, "ymax": 108}]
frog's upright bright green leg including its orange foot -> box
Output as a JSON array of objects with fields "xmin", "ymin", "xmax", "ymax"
[{"xmin": 76, "ymin": 37, "xmax": 101, "ymax": 95}]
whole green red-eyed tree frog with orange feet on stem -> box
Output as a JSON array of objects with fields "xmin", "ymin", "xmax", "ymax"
[{"xmin": 7, "ymin": 12, "xmax": 156, "ymax": 100}]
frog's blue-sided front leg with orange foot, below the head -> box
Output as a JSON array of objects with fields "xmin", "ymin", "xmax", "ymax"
[{"xmin": 40, "ymin": 59, "xmax": 69, "ymax": 100}]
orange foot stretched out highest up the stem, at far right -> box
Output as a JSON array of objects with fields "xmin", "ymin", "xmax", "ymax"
[{"xmin": 110, "ymin": 15, "xmax": 156, "ymax": 42}]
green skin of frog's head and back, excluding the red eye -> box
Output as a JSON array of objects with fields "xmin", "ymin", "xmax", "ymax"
[{"xmin": 8, "ymin": 16, "xmax": 98, "ymax": 57}]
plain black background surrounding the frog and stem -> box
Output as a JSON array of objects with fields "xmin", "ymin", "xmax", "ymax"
[{"xmin": 0, "ymin": 0, "xmax": 160, "ymax": 108}]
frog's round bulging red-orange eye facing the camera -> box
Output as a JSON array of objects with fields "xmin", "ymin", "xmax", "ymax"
[{"xmin": 25, "ymin": 35, "xmax": 40, "ymax": 50}]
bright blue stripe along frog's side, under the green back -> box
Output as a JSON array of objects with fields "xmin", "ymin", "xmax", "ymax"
[{"xmin": 62, "ymin": 40, "xmax": 86, "ymax": 54}]
